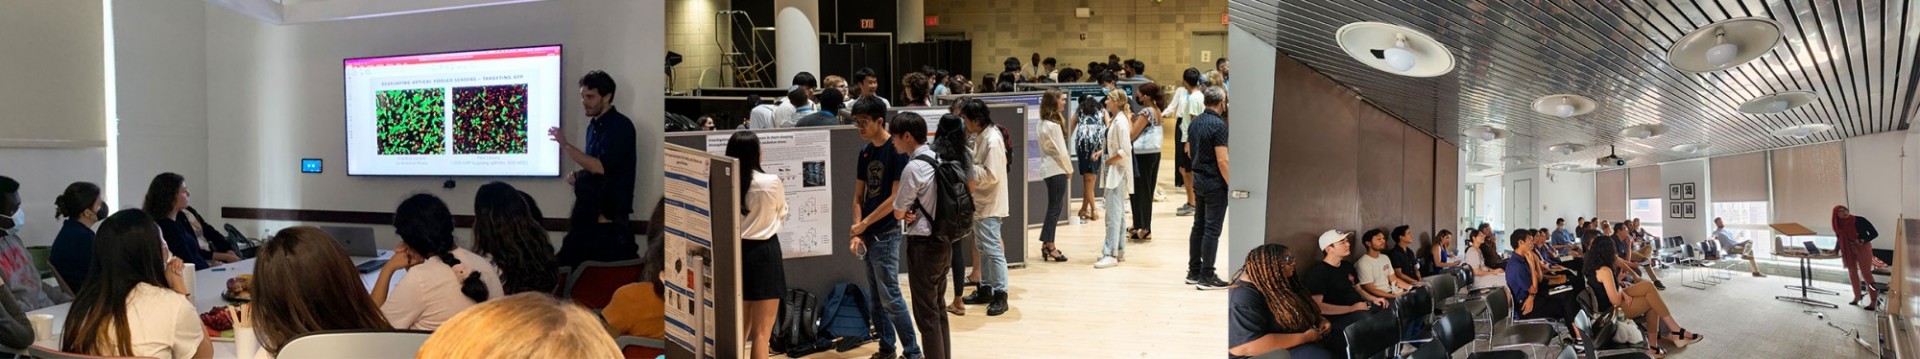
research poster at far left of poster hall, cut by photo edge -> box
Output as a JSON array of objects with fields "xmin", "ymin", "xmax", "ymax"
[{"xmin": 662, "ymin": 146, "xmax": 714, "ymax": 355}]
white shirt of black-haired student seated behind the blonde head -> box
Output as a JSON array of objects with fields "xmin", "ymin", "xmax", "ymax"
[{"xmin": 380, "ymin": 248, "xmax": 505, "ymax": 330}]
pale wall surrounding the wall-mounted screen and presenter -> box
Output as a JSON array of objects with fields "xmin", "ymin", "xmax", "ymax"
[{"xmin": 200, "ymin": 0, "xmax": 666, "ymax": 246}]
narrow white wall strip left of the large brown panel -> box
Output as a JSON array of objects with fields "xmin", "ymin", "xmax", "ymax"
[{"xmin": 1223, "ymin": 27, "xmax": 1284, "ymax": 273}]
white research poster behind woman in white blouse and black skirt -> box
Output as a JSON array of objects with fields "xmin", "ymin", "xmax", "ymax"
[{"xmin": 707, "ymin": 131, "xmax": 835, "ymax": 259}]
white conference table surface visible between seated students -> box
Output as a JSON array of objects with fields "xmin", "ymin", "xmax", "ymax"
[{"xmin": 13, "ymin": 250, "xmax": 407, "ymax": 359}]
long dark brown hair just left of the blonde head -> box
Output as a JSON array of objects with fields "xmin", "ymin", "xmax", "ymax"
[{"xmin": 252, "ymin": 227, "xmax": 394, "ymax": 353}]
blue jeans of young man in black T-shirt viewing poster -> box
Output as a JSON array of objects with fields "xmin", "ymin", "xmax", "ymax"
[{"xmin": 864, "ymin": 230, "xmax": 920, "ymax": 357}]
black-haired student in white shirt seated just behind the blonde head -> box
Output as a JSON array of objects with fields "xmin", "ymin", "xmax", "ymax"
[{"xmin": 372, "ymin": 194, "xmax": 501, "ymax": 330}]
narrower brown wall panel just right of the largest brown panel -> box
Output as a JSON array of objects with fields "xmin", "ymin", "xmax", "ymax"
[{"xmin": 1352, "ymin": 104, "xmax": 1415, "ymax": 230}]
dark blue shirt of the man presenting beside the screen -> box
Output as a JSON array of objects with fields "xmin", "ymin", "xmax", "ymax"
[{"xmin": 582, "ymin": 106, "xmax": 639, "ymax": 221}]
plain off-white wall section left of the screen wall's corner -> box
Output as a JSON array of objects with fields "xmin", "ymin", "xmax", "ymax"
[{"xmin": 109, "ymin": 0, "xmax": 209, "ymax": 215}]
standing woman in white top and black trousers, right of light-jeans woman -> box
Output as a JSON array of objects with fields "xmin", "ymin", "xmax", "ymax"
[{"xmin": 1127, "ymin": 83, "xmax": 1165, "ymax": 240}]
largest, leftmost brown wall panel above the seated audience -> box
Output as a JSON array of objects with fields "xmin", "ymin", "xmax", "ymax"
[{"xmin": 1265, "ymin": 56, "xmax": 1371, "ymax": 259}]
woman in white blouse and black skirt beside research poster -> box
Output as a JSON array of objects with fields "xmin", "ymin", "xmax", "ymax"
[{"xmin": 726, "ymin": 131, "xmax": 787, "ymax": 359}]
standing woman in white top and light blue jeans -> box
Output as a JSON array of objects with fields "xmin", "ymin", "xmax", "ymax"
[{"xmin": 1092, "ymin": 88, "xmax": 1128, "ymax": 269}]
